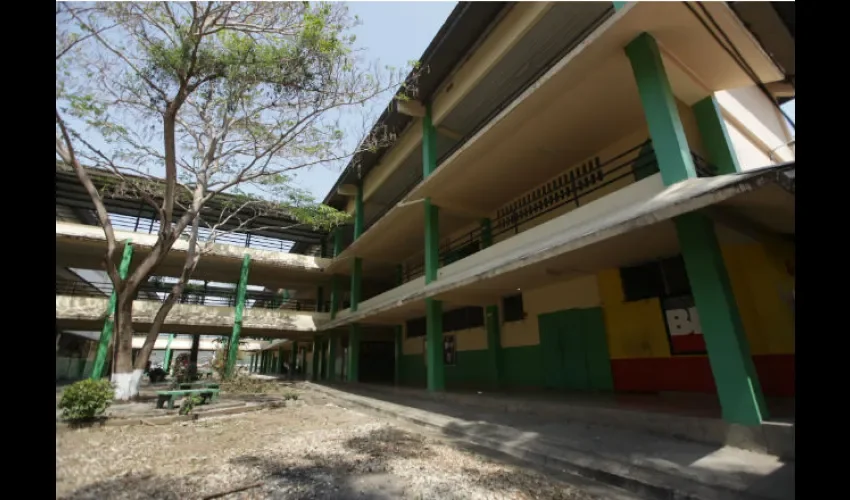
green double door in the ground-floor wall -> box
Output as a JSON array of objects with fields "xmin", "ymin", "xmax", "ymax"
[{"xmin": 537, "ymin": 307, "xmax": 613, "ymax": 391}]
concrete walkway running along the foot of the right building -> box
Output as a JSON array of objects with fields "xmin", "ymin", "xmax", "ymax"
[{"xmin": 307, "ymin": 384, "xmax": 795, "ymax": 500}]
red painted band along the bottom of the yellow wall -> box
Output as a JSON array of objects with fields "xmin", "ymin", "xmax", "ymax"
[{"xmin": 611, "ymin": 354, "xmax": 795, "ymax": 397}]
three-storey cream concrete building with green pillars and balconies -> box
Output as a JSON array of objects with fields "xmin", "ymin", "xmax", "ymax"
[{"xmin": 57, "ymin": 2, "xmax": 795, "ymax": 425}]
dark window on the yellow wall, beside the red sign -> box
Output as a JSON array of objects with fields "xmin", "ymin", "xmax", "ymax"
[{"xmin": 620, "ymin": 255, "xmax": 691, "ymax": 302}]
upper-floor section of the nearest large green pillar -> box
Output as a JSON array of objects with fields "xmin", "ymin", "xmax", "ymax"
[{"xmin": 626, "ymin": 33, "xmax": 696, "ymax": 186}]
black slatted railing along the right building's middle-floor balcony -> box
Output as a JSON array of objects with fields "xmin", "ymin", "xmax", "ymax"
[{"xmin": 402, "ymin": 141, "xmax": 717, "ymax": 282}]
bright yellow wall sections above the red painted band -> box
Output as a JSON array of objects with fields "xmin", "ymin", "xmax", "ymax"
[{"xmin": 598, "ymin": 239, "xmax": 794, "ymax": 359}]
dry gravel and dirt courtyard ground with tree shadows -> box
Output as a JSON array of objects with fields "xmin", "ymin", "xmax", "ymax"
[{"xmin": 56, "ymin": 397, "xmax": 616, "ymax": 500}]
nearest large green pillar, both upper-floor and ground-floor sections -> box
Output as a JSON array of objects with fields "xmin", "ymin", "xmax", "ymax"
[{"xmin": 626, "ymin": 33, "xmax": 767, "ymax": 425}]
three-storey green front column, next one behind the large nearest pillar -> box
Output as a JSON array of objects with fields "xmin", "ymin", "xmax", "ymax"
[{"xmin": 422, "ymin": 104, "xmax": 446, "ymax": 391}]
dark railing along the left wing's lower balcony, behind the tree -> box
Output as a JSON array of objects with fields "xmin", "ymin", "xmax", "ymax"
[{"xmin": 56, "ymin": 280, "xmax": 320, "ymax": 311}]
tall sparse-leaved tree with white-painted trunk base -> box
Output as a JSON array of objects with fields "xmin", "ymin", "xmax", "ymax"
[{"xmin": 56, "ymin": 2, "xmax": 413, "ymax": 399}]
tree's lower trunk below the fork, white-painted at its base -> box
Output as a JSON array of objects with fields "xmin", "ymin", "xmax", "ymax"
[{"xmin": 112, "ymin": 289, "xmax": 143, "ymax": 401}]
